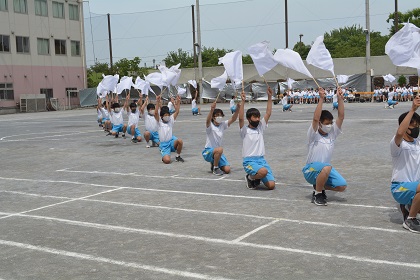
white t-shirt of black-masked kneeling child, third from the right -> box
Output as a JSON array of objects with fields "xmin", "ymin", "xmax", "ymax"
[{"xmin": 240, "ymin": 118, "xmax": 267, "ymax": 158}]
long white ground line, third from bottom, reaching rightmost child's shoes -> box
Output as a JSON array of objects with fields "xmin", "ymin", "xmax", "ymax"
[{"xmin": 0, "ymin": 191, "xmax": 407, "ymax": 234}]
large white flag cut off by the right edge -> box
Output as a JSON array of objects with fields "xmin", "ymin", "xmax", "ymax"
[{"xmin": 385, "ymin": 23, "xmax": 420, "ymax": 69}]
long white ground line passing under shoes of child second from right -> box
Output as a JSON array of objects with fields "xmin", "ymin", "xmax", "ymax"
[{"xmin": 0, "ymin": 174, "xmax": 396, "ymax": 210}]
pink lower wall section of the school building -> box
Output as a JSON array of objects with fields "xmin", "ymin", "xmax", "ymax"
[{"xmin": 0, "ymin": 65, "xmax": 84, "ymax": 107}]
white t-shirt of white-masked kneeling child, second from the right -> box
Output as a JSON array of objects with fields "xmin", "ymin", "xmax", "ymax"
[{"xmin": 306, "ymin": 122, "xmax": 341, "ymax": 164}]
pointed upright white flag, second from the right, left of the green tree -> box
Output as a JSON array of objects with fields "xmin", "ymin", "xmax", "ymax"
[{"xmin": 306, "ymin": 36, "xmax": 335, "ymax": 76}]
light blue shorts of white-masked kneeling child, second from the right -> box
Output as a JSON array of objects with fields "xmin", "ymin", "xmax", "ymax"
[{"xmin": 302, "ymin": 162, "xmax": 347, "ymax": 188}]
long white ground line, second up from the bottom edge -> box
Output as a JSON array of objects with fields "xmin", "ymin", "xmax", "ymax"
[{"xmin": 4, "ymin": 215, "xmax": 420, "ymax": 269}]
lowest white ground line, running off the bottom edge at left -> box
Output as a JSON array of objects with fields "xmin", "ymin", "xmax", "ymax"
[{"xmin": 0, "ymin": 240, "xmax": 228, "ymax": 280}]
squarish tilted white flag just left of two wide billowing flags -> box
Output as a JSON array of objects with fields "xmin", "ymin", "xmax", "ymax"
[{"xmin": 248, "ymin": 41, "xmax": 277, "ymax": 76}]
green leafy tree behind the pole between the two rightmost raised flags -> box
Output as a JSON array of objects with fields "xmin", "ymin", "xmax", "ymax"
[{"xmin": 324, "ymin": 25, "xmax": 389, "ymax": 58}]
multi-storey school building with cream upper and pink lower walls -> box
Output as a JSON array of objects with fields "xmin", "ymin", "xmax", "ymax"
[{"xmin": 0, "ymin": 0, "xmax": 86, "ymax": 112}]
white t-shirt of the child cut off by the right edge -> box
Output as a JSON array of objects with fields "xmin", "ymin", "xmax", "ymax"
[{"xmin": 390, "ymin": 136, "xmax": 420, "ymax": 182}]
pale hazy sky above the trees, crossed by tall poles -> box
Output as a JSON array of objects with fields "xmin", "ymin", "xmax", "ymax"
[{"xmin": 83, "ymin": 0, "xmax": 420, "ymax": 68}]
